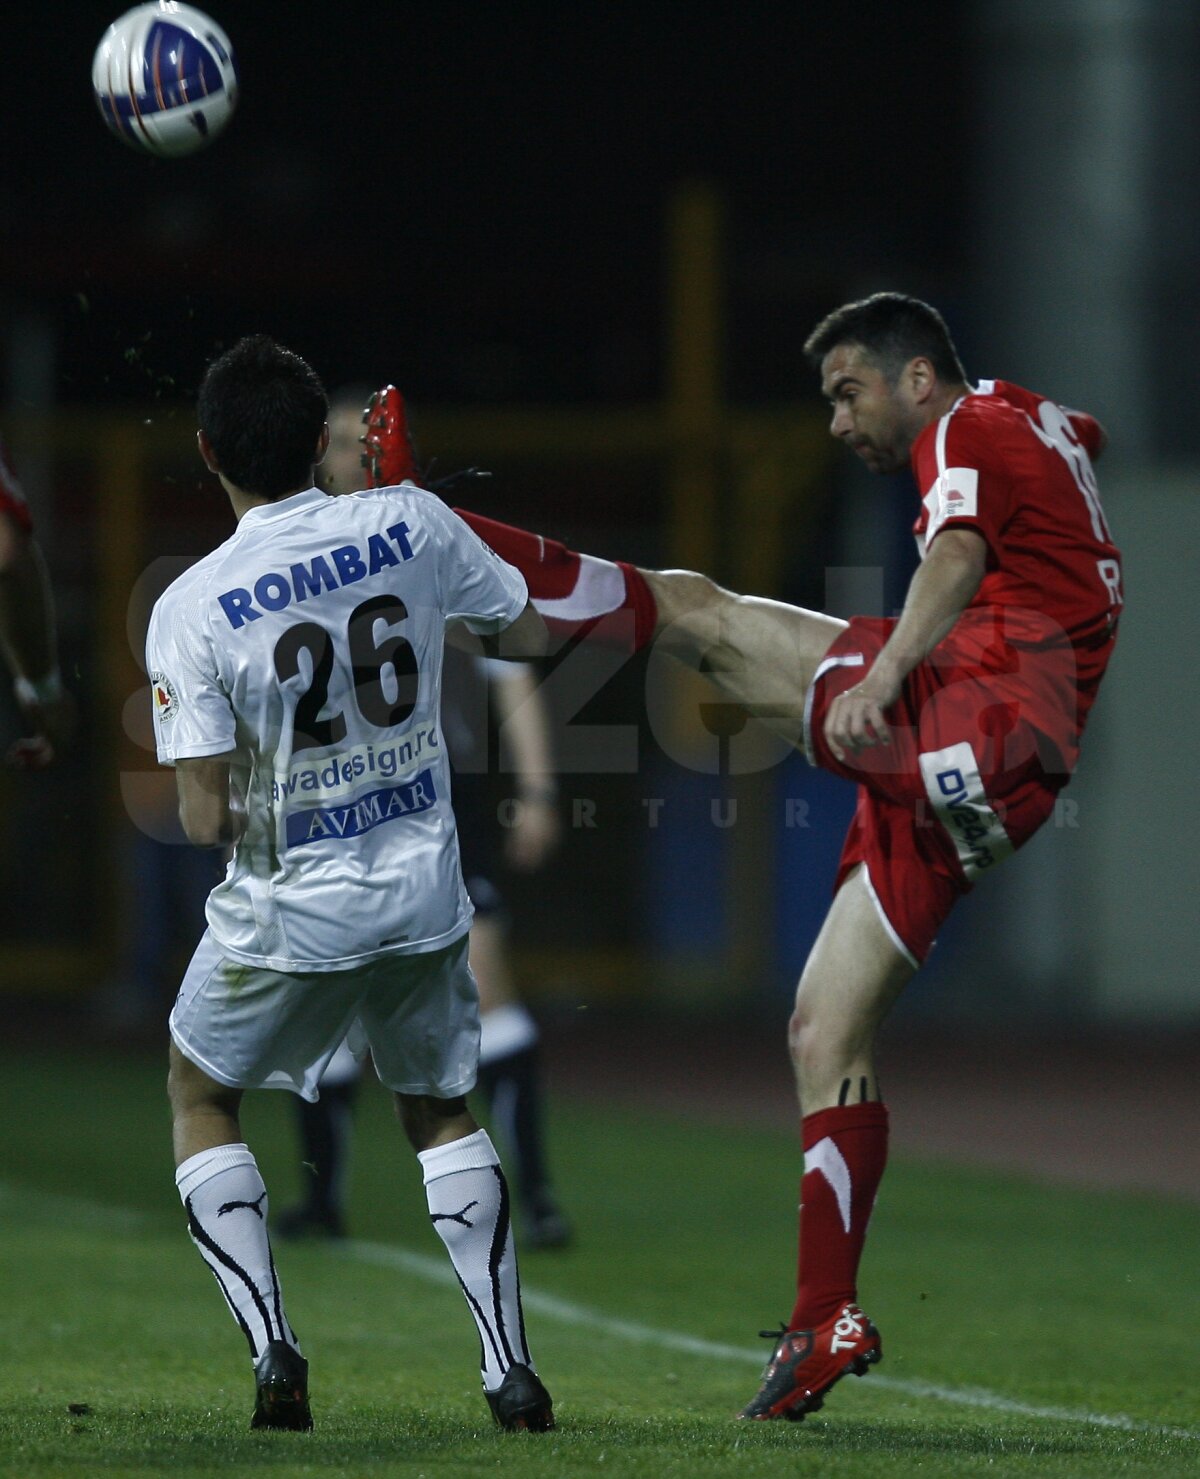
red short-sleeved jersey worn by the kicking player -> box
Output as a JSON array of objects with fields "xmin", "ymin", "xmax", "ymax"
[{"xmin": 913, "ymin": 380, "xmax": 1122, "ymax": 771}]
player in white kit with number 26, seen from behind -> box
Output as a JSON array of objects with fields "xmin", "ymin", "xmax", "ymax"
[{"xmin": 146, "ymin": 336, "xmax": 553, "ymax": 1430}]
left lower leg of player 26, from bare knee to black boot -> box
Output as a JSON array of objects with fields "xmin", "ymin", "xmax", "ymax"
[{"xmin": 170, "ymin": 1044, "xmax": 312, "ymax": 1432}]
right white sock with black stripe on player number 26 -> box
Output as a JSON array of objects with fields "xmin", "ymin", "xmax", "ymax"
[{"xmin": 419, "ymin": 1130, "xmax": 533, "ymax": 1392}]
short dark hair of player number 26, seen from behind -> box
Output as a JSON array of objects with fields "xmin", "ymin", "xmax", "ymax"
[{"xmin": 195, "ymin": 334, "xmax": 328, "ymax": 498}]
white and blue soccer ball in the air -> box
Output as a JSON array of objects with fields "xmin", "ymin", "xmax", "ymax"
[{"xmin": 92, "ymin": 0, "xmax": 238, "ymax": 158}]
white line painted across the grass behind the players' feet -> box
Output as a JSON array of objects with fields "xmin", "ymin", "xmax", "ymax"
[{"xmin": 0, "ymin": 1182, "xmax": 1200, "ymax": 1442}]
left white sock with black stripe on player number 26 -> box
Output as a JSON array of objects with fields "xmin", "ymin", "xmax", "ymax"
[{"xmin": 175, "ymin": 1145, "xmax": 300, "ymax": 1359}]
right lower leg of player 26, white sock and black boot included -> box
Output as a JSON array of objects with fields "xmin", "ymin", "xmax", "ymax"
[{"xmin": 397, "ymin": 1094, "xmax": 555, "ymax": 1433}]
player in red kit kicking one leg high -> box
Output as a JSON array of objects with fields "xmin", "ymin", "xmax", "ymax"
[{"xmin": 361, "ymin": 293, "xmax": 1122, "ymax": 1420}]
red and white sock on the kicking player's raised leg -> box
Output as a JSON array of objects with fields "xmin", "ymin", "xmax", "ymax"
[{"xmin": 454, "ymin": 509, "xmax": 658, "ymax": 652}]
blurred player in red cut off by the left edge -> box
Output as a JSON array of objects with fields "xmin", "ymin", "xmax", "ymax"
[{"xmin": 0, "ymin": 444, "xmax": 74, "ymax": 769}]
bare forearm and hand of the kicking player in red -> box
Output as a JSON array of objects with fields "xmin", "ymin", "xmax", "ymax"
[{"xmin": 826, "ymin": 528, "xmax": 987, "ymax": 760}]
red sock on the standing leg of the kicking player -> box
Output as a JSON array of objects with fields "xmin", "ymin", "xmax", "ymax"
[{"xmin": 789, "ymin": 1102, "xmax": 888, "ymax": 1330}]
